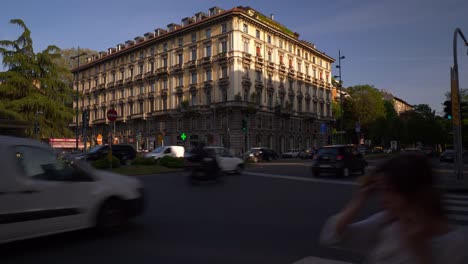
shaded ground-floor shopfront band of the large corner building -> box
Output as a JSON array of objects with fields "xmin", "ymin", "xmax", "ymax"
[{"xmin": 83, "ymin": 102, "xmax": 333, "ymax": 155}]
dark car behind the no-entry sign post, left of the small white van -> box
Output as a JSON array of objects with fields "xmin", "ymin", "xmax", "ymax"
[{"xmin": 73, "ymin": 144, "xmax": 137, "ymax": 164}]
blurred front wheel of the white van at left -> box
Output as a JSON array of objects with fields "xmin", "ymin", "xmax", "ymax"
[{"xmin": 96, "ymin": 198, "xmax": 127, "ymax": 233}]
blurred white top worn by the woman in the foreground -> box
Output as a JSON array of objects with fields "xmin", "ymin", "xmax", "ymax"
[{"xmin": 320, "ymin": 212, "xmax": 468, "ymax": 264}]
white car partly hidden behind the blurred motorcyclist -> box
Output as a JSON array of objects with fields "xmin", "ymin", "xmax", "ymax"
[{"xmin": 185, "ymin": 146, "xmax": 244, "ymax": 174}]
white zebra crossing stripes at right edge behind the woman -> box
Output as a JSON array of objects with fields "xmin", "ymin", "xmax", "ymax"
[{"xmin": 444, "ymin": 193, "xmax": 468, "ymax": 227}]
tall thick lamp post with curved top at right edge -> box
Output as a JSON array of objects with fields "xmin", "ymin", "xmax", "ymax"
[{"xmin": 450, "ymin": 28, "xmax": 468, "ymax": 180}]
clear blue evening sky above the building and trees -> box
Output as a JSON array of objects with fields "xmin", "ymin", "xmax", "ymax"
[{"xmin": 0, "ymin": 0, "xmax": 468, "ymax": 111}]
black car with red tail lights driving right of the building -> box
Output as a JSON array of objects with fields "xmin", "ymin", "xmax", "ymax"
[{"xmin": 312, "ymin": 145, "xmax": 367, "ymax": 177}]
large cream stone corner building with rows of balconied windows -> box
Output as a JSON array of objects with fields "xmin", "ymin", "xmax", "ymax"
[{"xmin": 72, "ymin": 7, "xmax": 334, "ymax": 154}]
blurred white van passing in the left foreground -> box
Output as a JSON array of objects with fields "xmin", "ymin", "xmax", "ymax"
[{"xmin": 0, "ymin": 136, "xmax": 144, "ymax": 243}]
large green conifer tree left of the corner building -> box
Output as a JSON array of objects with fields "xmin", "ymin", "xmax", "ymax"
[{"xmin": 0, "ymin": 19, "xmax": 73, "ymax": 137}]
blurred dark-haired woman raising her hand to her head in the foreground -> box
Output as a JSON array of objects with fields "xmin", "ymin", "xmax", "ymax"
[{"xmin": 321, "ymin": 153, "xmax": 468, "ymax": 264}]
